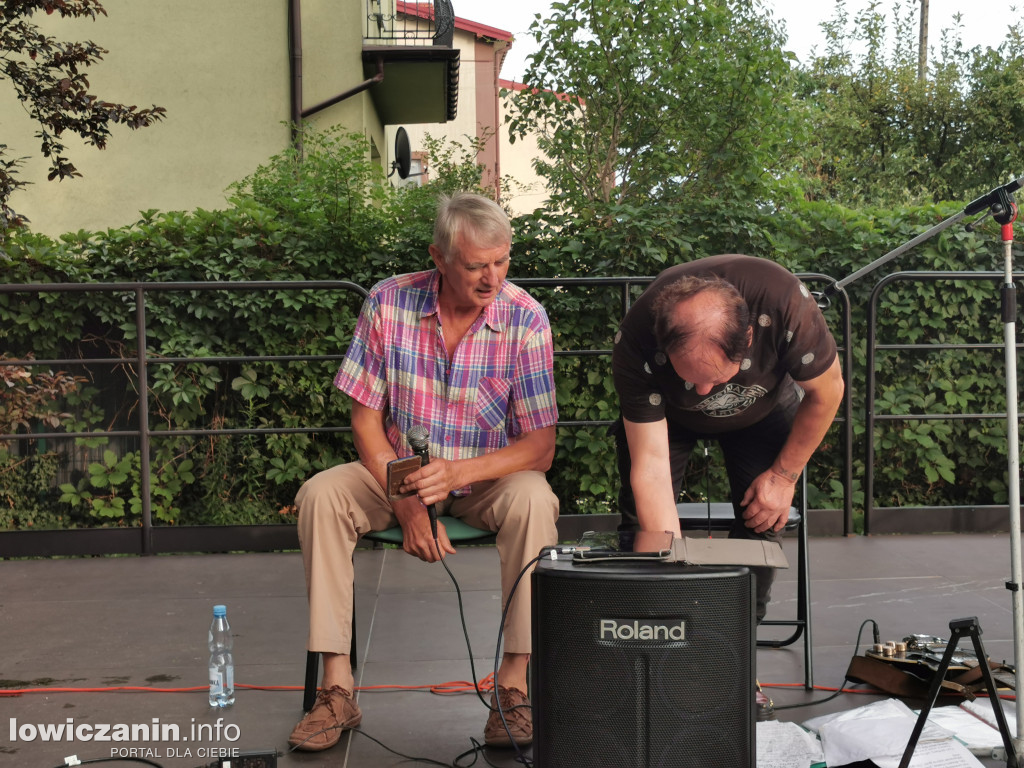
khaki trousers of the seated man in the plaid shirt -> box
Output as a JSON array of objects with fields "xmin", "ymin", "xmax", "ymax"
[{"xmin": 295, "ymin": 462, "xmax": 558, "ymax": 653}]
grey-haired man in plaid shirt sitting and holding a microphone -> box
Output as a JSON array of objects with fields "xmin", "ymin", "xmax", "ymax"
[{"xmin": 289, "ymin": 194, "xmax": 558, "ymax": 752}]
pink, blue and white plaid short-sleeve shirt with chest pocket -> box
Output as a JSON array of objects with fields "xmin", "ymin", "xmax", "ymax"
[{"xmin": 334, "ymin": 269, "xmax": 558, "ymax": 487}]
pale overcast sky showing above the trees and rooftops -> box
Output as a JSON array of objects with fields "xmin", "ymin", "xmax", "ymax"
[{"xmin": 452, "ymin": 0, "xmax": 1016, "ymax": 80}]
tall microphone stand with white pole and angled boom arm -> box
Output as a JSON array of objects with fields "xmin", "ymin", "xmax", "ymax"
[{"xmin": 818, "ymin": 176, "xmax": 1024, "ymax": 768}]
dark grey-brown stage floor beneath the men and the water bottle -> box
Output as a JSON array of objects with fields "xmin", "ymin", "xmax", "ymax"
[{"xmin": 0, "ymin": 535, "xmax": 1013, "ymax": 768}]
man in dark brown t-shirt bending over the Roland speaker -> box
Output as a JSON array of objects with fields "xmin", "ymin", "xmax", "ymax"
[{"xmin": 612, "ymin": 254, "xmax": 844, "ymax": 622}]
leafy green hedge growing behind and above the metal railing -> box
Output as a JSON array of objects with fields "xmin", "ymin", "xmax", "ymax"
[{"xmin": 0, "ymin": 129, "xmax": 1006, "ymax": 528}]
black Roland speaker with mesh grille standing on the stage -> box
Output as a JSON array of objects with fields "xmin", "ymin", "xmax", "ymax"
[{"xmin": 530, "ymin": 560, "xmax": 757, "ymax": 768}]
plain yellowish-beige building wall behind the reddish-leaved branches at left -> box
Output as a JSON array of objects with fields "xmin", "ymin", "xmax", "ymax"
[{"xmin": 0, "ymin": 0, "xmax": 384, "ymax": 237}]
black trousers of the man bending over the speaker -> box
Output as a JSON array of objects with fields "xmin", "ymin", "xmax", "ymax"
[{"xmin": 613, "ymin": 397, "xmax": 800, "ymax": 623}]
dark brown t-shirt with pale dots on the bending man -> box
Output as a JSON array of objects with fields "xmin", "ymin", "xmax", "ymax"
[{"xmin": 611, "ymin": 254, "xmax": 837, "ymax": 434}]
